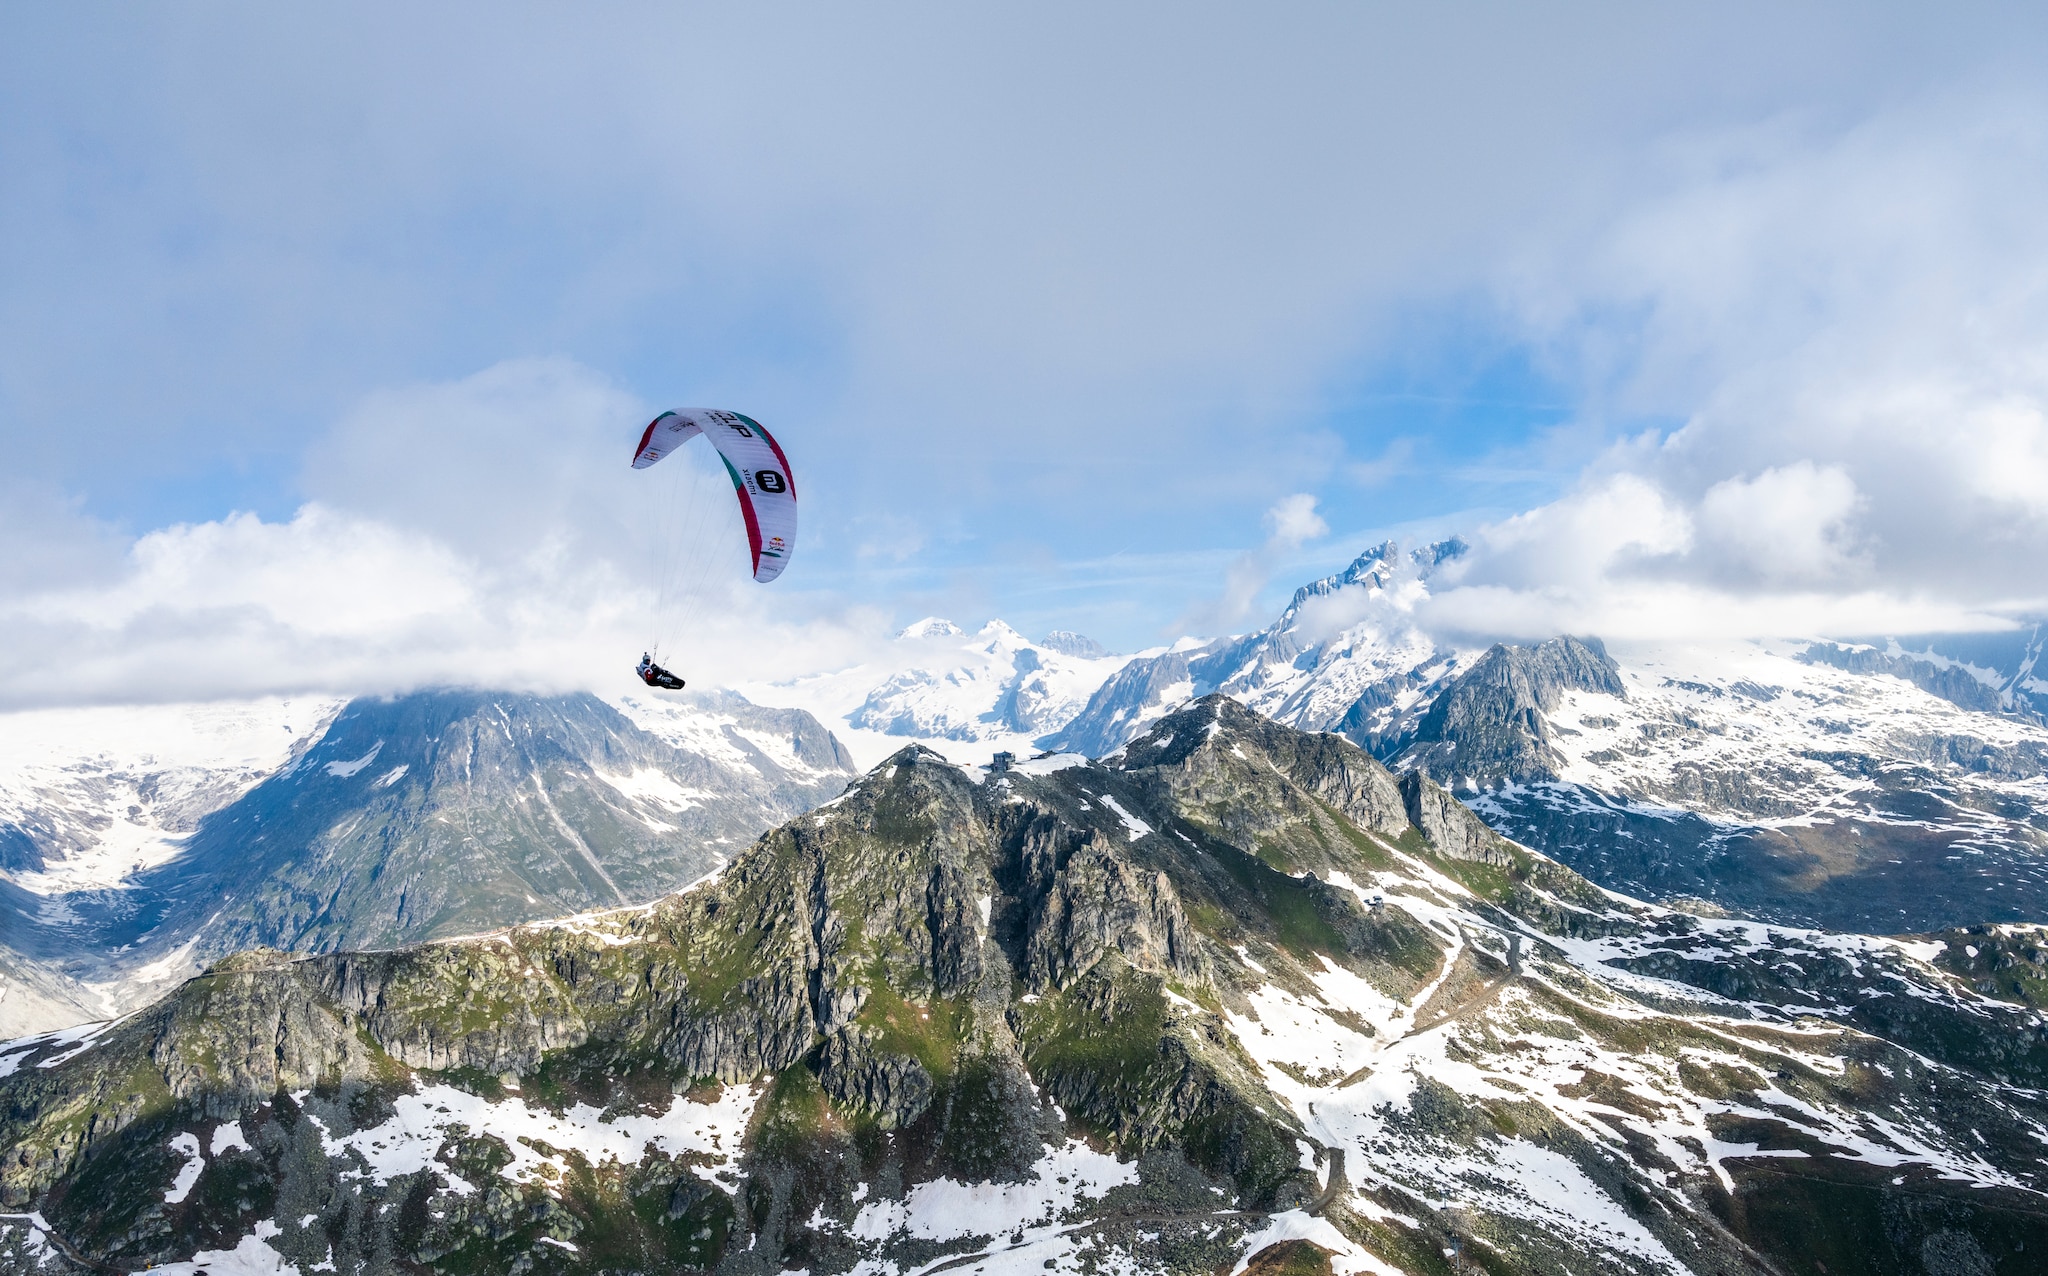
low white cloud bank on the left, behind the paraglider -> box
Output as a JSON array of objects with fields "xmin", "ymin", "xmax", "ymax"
[{"xmin": 0, "ymin": 360, "xmax": 921, "ymax": 707}]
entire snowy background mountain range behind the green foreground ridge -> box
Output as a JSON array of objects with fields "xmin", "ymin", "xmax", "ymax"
[{"xmin": 16, "ymin": 541, "xmax": 2048, "ymax": 1032}]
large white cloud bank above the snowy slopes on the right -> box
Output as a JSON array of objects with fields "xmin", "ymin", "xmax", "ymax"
[{"xmin": 1430, "ymin": 86, "xmax": 2048, "ymax": 637}]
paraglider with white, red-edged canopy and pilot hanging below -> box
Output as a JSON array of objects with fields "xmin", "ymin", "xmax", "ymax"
[{"xmin": 633, "ymin": 408, "xmax": 797, "ymax": 690}]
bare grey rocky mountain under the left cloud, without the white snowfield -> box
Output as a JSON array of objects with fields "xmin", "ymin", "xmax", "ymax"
[{"xmin": 0, "ymin": 688, "xmax": 852, "ymax": 1040}]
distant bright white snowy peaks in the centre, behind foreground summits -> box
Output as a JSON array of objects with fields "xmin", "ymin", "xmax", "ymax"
[{"xmin": 741, "ymin": 616, "xmax": 1133, "ymax": 766}]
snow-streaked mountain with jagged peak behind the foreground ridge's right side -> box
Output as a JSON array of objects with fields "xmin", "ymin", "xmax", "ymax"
[{"xmin": 1044, "ymin": 541, "xmax": 2048, "ymax": 932}]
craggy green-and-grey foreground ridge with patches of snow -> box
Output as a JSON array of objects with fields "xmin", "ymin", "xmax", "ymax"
[{"xmin": 0, "ymin": 696, "xmax": 2048, "ymax": 1274}]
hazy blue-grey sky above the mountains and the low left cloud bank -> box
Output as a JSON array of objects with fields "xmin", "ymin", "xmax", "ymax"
[{"xmin": 0, "ymin": 4, "xmax": 2048, "ymax": 704}]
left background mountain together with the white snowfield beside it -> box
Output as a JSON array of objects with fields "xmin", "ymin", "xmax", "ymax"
[{"xmin": 0, "ymin": 690, "xmax": 854, "ymax": 1030}]
